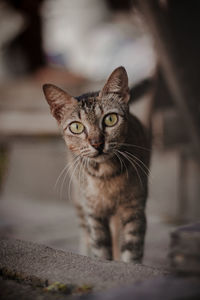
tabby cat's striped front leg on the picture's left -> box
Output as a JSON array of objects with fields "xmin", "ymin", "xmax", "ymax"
[{"xmin": 88, "ymin": 213, "xmax": 112, "ymax": 260}]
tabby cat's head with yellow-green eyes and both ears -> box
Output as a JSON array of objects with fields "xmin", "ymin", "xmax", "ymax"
[{"xmin": 43, "ymin": 67, "xmax": 130, "ymax": 162}]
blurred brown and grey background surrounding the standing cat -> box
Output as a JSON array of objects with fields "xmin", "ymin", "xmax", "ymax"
[{"xmin": 0, "ymin": 0, "xmax": 200, "ymax": 267}]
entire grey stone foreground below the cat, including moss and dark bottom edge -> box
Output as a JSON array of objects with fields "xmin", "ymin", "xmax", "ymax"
[{"xmin": 0, "ymin": 239, "xmax": 200, "ymax": 300}]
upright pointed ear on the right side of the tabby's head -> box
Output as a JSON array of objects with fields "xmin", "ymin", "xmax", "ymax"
[{"xmin": 99, "ymin": 66, "xmax": 129, "ymax": 102}]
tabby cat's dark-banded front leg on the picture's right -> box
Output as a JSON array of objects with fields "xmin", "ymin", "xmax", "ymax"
[{"xmin": 121, "ymin": 205, "xmax": 146, "ymax": 263}]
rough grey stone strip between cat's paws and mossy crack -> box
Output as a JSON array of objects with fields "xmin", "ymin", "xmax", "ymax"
[{"xmin": 0, "ymin": 239, "xmax": 167, "ymax": 291}]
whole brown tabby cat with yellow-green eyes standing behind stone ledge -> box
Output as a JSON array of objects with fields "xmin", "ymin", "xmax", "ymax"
[{"xmin": 43, "ymin": 66, "xmax": 151, "ymax": 263}]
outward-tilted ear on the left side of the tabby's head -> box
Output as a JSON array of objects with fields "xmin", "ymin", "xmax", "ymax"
[{"xmin": 43, "ymin": 84, "xmax": 77, "ymax": 122}]
